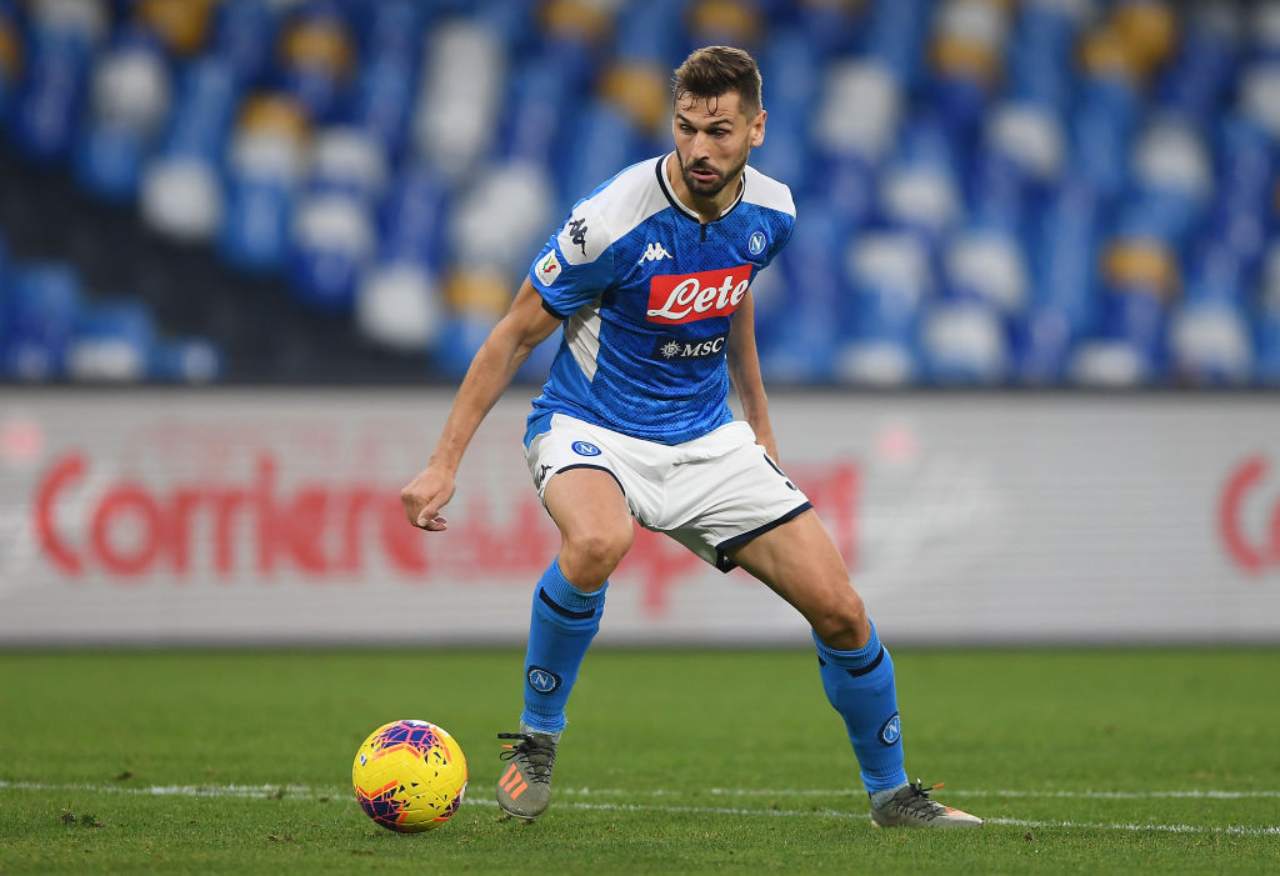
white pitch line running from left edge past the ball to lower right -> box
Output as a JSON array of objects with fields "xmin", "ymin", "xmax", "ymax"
[{"xmin": 0, "ymin": 780, "xmax": 1280, "ymax": 836}]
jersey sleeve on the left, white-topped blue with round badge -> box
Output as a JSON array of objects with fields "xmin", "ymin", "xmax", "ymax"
[{"xmin": 529, "ymin": 201, "xmax": 613, "ymax": 319}]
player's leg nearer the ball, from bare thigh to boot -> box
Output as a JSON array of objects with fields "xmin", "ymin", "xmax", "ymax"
[{"xmin": 498, "ymin": 467, "xmax": 635, "ymax": 820}]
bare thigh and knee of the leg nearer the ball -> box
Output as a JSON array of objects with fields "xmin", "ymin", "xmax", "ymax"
[{"xmin": 543, "ymin": 467, "xmax": 635, "ymax": 560}]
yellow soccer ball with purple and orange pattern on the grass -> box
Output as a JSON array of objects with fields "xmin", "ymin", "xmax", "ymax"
[{"xmin": 351, "ymin": 721, "xmax": 467, "ymax": 834}]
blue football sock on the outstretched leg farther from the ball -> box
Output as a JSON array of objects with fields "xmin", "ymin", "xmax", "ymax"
[{"xmin": 813, "ymin": 624, "xmax": 906, "ymax": 794}]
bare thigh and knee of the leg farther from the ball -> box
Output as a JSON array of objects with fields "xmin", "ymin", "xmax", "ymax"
[{"xmin": 728, "ymin": 508, "xmax": 863, "ymax": 634}]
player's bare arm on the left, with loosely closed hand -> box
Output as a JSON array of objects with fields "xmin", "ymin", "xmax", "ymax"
[{"xmin": 401, "ymin": 278, "xmax": 561, "ymax": 531}]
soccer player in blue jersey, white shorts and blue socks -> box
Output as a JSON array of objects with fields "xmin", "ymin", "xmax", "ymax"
[{"xmin": 401, "ymin": 46, "xmax": 982, "ymax": 826}]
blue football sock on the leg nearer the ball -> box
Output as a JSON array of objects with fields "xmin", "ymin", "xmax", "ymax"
[{"xmin": 520, "ymin": 557, "xmax": 609, "ymax": 734}]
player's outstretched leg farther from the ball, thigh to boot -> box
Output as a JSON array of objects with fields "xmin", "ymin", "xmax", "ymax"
[{"xmin": 728, "ymin": 510, "xmax": 982, "ymax": 827}]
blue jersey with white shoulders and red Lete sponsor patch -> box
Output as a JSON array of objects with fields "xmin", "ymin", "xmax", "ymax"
[{"xmin": 525, "ymin": 155, "xmax": 796, "ymax": 444}]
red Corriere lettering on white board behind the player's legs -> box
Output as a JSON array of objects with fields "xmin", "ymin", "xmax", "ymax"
[{"xmin": 31, "ymin": 451, "xmax": 858, "ymax": 617}]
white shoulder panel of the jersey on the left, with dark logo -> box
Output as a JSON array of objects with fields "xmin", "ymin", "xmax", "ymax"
[{"xmin": 557, "ymin": 158, "xmax": 668, "ymax": 265}]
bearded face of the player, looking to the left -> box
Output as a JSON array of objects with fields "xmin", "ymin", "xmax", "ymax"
[{"xmin": 672, "ymin": 91, "xmax": 767, "ymax": 197}]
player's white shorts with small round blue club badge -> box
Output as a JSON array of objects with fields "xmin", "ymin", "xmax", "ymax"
[{"xmin": 525, "ymin": 414, "xmax": 812, "ymax": 571}]
